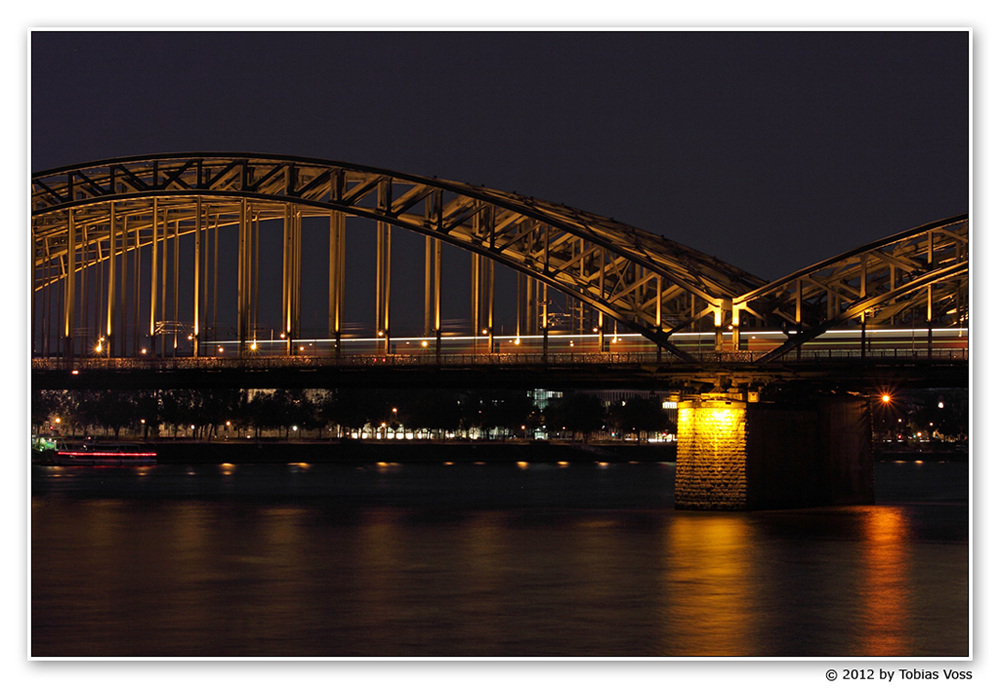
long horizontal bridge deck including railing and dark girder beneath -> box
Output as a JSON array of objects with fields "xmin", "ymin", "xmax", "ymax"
[{"xmin": 32, "ymin": 348, "xmax": 969, "ymax": 389}]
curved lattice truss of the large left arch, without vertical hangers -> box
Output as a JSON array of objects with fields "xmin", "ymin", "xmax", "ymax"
[{"xmin": 32, "ymin": 153, "xmax": 764, "ymax": 358}]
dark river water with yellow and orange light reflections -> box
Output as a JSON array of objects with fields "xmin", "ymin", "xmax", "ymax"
[{"xmin": 29, "ymin": 461, "xmax": 970, "ymax": 658}]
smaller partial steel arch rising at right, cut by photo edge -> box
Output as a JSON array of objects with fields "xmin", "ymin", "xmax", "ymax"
[{"xmin": 733, "ymin": 213, "xmax": 969, "ymax": 362}]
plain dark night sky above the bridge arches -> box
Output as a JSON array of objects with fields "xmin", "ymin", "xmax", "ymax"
[{"xmin": 30, "ymin": 31, "xmax": 969, "ymax": 279}]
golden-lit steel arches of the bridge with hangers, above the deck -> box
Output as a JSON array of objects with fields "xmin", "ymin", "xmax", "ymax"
[{"xmin": 31, "ymin": 153, "xmax": 969, "ymax": 362}]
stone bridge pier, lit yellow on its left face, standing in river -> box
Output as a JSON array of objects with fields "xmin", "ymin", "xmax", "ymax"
[{"xmin": 674, "ymin": 394, "xmax": 875, "ymax": 510}]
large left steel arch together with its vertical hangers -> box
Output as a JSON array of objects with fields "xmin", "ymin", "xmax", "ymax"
[{"xmin": 32, "ymin": 153, "xmax": 764, "ymax": 358}]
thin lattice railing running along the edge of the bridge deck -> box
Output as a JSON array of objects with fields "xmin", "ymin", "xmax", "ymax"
[{"xmin": 31, "ymin": 348, "xmax": 969, "ymax": 372}]
